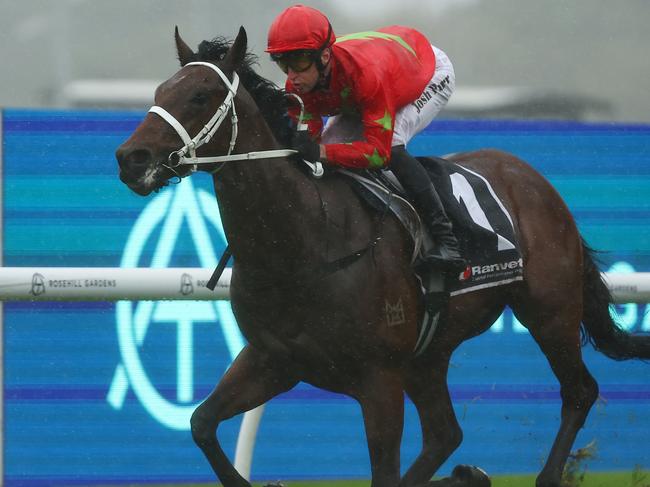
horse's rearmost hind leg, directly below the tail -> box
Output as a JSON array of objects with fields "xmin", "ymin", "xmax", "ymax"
[{"xmin": 513, "ymin": 302, "xmax": 598, "ymax": 487}]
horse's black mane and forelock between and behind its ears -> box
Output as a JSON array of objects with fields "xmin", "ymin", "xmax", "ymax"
[{"xmin": 195, "ymin": 37, "xmax": 291, "ymax": 145}]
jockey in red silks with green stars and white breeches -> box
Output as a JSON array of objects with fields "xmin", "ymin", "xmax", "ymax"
[{"xmin": 266, "ymin": 5, "xmax": 467, "ymax": 272}]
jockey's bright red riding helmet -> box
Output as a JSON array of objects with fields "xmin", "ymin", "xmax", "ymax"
[{"xmin": 266, "ymin": 5, "xmax": 336, "ymax": 54}]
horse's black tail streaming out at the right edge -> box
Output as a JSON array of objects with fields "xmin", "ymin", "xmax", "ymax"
[{"xmin": 582, "ymin": 241, "xmax": 650, "ymax": 360}]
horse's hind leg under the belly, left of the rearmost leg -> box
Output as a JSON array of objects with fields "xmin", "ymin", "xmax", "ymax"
[{"xmin": 400, "ymin": 356, "xmax": 463, "ymax": 487}]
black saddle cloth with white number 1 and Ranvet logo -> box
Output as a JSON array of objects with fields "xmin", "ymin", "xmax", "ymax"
[{"xmin": 339, "ymin": 157, "xmax": 523, "ymax": 296}]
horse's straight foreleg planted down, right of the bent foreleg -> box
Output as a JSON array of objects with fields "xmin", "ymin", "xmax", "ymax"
[{"xmin": 354, "ymin": 368, "xmax": 404, "ymax": 487}]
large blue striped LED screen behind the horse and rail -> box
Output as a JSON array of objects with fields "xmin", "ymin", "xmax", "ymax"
[{"xmin": 2, "ymin": 110, "xmax": 650, "ymax": 486}]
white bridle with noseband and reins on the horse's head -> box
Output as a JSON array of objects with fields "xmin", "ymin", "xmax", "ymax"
[{"xmin": 149, "ymin": 61, "xmax": 323, "ymax": 182}]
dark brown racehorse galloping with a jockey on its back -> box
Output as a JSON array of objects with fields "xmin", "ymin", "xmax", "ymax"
[{"xmin": 116, "ymin": 28, "xmax": 650, "ymax": 487}]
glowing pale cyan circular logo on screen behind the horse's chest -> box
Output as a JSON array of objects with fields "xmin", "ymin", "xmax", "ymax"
[{"xmin": 107, "ymin": 179, "xmax": 244, "ymax": 430}]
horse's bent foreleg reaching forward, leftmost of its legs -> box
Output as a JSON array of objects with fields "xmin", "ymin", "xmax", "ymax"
[{"xmin": 191, "ymin": 345, "xmax": 297, "ymax": 487}]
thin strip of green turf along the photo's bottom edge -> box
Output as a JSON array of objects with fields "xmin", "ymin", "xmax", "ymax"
[{"xmin": 129, "ymin": 470, "xmax": 650, "ymax": 487}]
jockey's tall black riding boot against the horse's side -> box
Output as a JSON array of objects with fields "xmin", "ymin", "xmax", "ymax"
[{"xmin": 390, "ymin": 145, "xmax": 467, "ymax": 272}]
